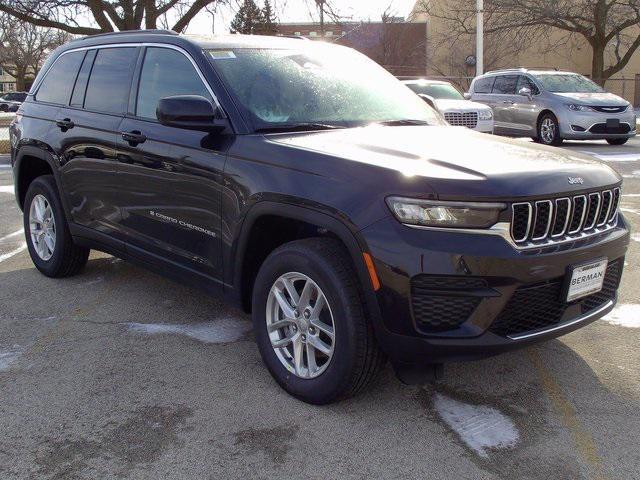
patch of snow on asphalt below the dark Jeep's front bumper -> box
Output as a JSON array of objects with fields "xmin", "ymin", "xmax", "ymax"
[{"xmin": 434, "ymin": 393, "xmax": 520, "ymax": 458}]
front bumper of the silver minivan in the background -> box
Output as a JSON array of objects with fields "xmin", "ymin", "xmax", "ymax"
[{"xmin": 558, "ymin": 109, "xmax": 637, "ymax": 140}]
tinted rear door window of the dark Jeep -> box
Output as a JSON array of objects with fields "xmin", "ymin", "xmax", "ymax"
[{"xmin": 84, "ymin": 47, "xmax": 137, "ymax": 113}]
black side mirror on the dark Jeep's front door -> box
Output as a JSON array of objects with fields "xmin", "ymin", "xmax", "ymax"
[{"xmin": 156, "ymin": 95, "xmax": 229, "ymax": 132}]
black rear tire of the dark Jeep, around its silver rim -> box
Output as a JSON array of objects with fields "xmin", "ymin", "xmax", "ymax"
[{"xmin": 23, "ymin": 175, "xmax": 90, "ymax": 278}]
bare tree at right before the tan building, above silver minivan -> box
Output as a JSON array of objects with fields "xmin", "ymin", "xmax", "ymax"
[{"xmin": 416, "ymin": 0, "xmax": 640, "ymax": 84}]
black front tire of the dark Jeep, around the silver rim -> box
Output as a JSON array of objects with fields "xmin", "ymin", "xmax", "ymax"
[{"xmin": 252, "ymin": 238, "xmax": 385, "ymax": 405}]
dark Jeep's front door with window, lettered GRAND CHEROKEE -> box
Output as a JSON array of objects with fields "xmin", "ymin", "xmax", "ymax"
[{"xmin": 118, "ymin": 46, "xmax": 228, "ymax": 280}]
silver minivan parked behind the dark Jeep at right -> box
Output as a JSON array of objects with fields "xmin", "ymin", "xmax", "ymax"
[{"xmin": 468, "ymin": 68, "xmax": 637, "ymax": 145}]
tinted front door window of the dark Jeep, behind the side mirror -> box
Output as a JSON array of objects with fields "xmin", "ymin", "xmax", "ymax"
[{"xmin": 136, "ymin": 48, "xmax": 213, "ymax": 118}]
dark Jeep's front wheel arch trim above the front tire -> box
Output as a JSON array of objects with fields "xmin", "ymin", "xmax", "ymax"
[{"xmin": 227, "ymin": 201, "xmax": 380, "ymax": 324}]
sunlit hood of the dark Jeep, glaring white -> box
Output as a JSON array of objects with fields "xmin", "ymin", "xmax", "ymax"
[{"xmin": 268, "ymin": 126, "xmax": 621, "ymax": 199}]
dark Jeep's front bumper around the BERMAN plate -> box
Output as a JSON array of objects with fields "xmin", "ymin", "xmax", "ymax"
[{"xmin": 361, "ymin": 215, "xmax": 629, "ymax": 363}]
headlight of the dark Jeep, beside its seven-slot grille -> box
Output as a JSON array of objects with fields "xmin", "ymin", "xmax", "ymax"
[{"xmin": 387, "ymin": 197, "xmax": 507, "ymax": 228}]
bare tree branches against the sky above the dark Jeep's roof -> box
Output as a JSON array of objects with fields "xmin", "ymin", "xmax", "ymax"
[{"xmin": 0, "ymin": 0, "xmax": 224, "ymax": 35}]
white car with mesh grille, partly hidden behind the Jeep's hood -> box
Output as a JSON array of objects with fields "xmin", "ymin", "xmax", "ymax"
[{"xmin": 402, "ymin": 79, "xmax": 493, "ymax": 133}]
